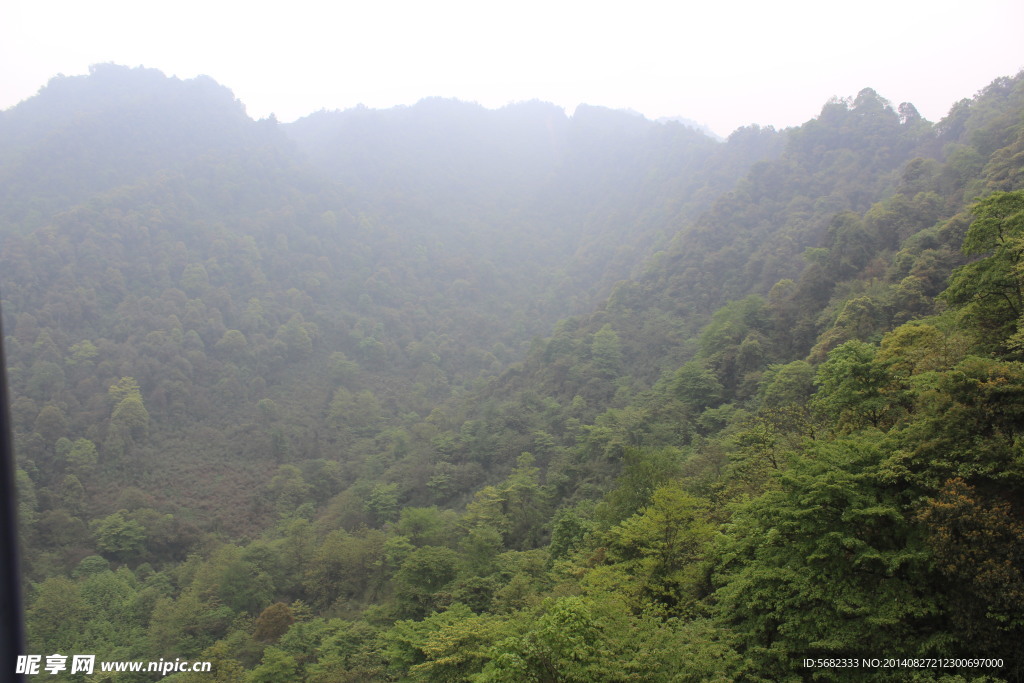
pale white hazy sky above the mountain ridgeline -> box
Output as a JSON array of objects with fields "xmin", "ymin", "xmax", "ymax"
[{"xmin": 0, "ymin": 0, "xmax": 1024, "ymax": 134}]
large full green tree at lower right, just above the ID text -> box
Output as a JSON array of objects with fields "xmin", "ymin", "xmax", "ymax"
[{"xmin": 713, "ymin": 439, "xmax": 951, "ymax": 680}]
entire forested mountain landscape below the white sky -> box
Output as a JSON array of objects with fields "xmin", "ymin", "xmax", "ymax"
[{"xmin": 0, "ymin": 66, "xmax": 1024, "ymax": 681}]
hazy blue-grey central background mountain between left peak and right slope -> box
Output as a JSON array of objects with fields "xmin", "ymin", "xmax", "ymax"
[{"xmin": 283, "ymin": 98, "xmax": 778, "ymax": 313}]
